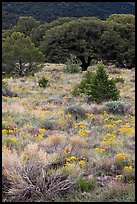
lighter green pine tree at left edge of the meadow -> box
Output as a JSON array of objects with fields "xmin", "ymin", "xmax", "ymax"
[{"xmin": 2, "ymin": 32, "xmax": 44, "ymax": 76}]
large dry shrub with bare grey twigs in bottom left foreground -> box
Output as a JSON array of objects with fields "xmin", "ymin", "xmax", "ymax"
[{"xmin": 2, "ymin": 148, "xmax": 75, "ymax": 202}]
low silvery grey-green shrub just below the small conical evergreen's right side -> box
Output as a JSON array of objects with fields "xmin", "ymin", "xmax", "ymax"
[{"xmin": 105, "ymin": 101, "xmax": 130, "ymax": 114}]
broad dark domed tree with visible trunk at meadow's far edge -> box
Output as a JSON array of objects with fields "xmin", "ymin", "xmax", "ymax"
[{"xmin": 40, "ymin": 17, "xmax": 109, "ymax": 71}]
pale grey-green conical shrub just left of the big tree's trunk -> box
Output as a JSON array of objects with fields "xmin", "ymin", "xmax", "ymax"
[{"xmin": 64, "ymin": 55, "xmax": 81, "ymax": 73}]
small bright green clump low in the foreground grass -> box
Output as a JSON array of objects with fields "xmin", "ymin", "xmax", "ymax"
[{"xmin": 77, "ymin": 177, "xmax": 96, "ymax": 192}]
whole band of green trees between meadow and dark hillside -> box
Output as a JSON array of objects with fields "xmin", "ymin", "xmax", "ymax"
[{"xmin": 2, "ymin": 14, "xmax": 135, "ymax": 76}]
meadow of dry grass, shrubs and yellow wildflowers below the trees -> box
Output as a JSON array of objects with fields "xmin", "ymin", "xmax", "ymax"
[{"xmin": 2, "ymin": 64, "xmax": 135, "ymax": 202}]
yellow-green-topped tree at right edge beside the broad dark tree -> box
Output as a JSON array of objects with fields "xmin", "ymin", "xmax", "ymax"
[{"xmin": 107, "ymin": 14, "xmax": 135, "ymax": 68}]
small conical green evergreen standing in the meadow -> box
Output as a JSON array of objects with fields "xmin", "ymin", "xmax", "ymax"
[{"xmin": 72, "ymin": 62, "xmax": 119, "ymax": 103}]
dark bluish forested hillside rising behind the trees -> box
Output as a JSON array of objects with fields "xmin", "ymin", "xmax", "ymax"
[{"xmin": 2, "ymin": 2, "xmax": 135, "ymax": 29}]
